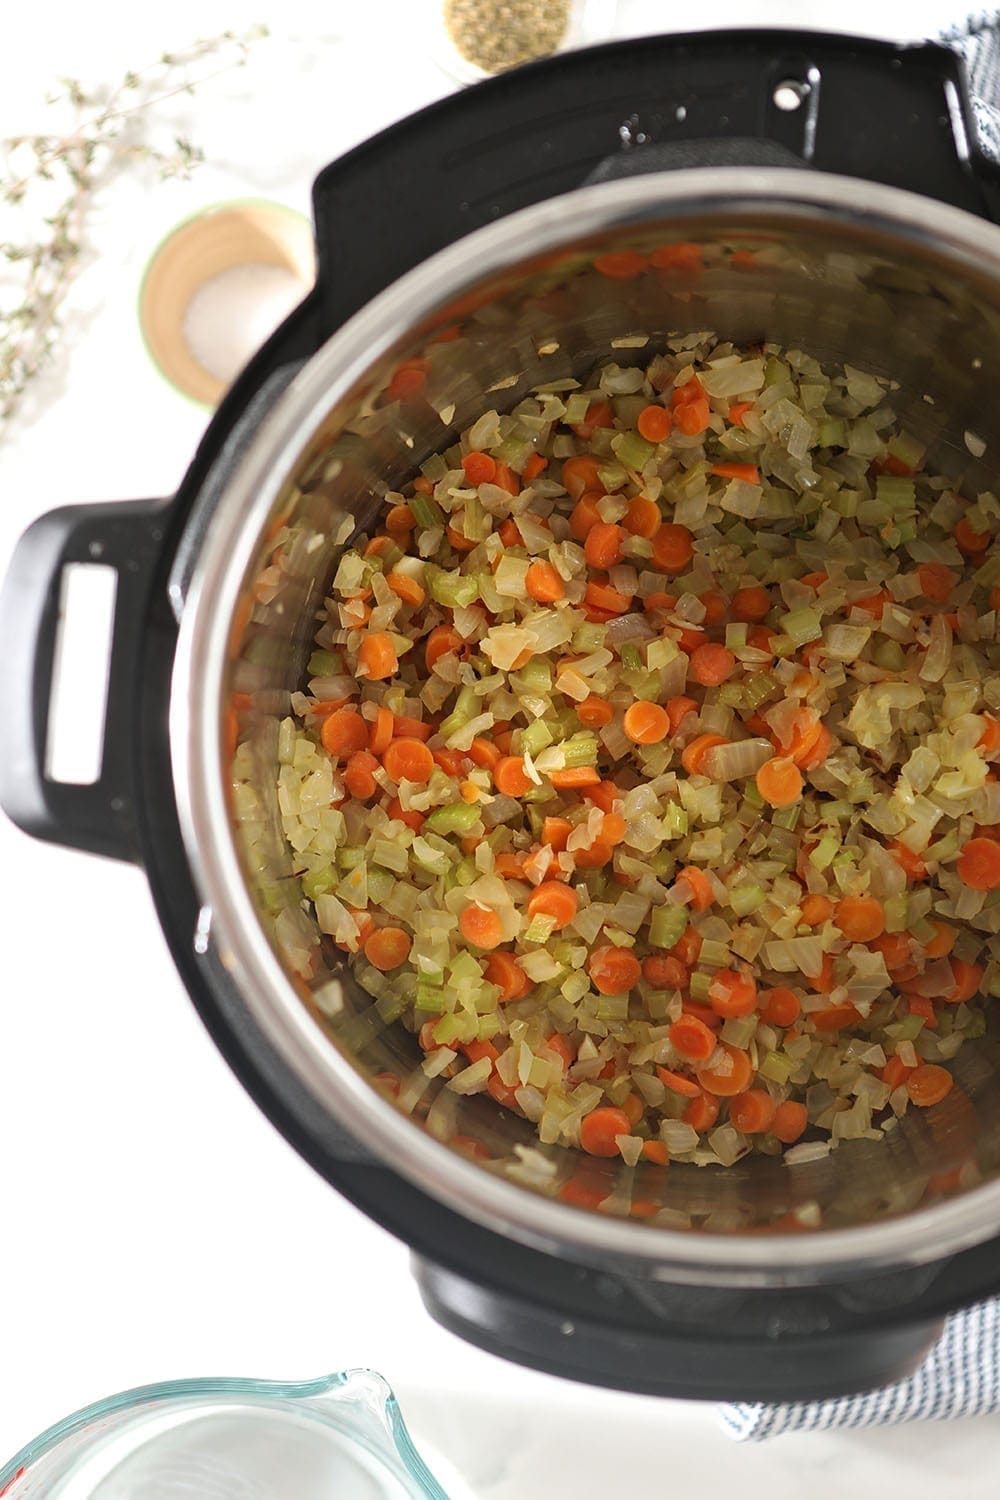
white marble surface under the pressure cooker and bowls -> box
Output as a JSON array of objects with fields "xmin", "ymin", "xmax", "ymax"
[{"xmin": 0, "ymin": 0, "xmax": 1000, "ymax": 1500}]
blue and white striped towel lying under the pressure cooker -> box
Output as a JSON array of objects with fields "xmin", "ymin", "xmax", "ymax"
[{"xmin": 721, "ymin": 11, "xmax": 1000, "ymax": 1443}]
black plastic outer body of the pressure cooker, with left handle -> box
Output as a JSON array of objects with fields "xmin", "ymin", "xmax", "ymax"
[{"xmin": 3, "ymin": 32, "xmax": 1000, "ymax": 1401}]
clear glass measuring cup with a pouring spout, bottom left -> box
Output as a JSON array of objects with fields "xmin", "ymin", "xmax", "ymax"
[{"xmin": 0, "ymin": 1370, "xmax": 448, "ymax": 1500}]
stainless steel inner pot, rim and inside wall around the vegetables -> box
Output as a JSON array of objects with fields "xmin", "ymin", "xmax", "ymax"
[{"xmin": 171, "ymin": 168, "xmax": 1000, "ymax": 1284}]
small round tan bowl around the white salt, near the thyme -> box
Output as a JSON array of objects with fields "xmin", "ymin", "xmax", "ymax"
[{"xmin": 139, "ymin": 200, "xmax": 316, "ymax": 408}]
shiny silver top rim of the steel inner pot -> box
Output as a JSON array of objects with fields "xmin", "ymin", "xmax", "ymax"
[{"xmin": 169, "ymin": 168, "xmax": 1000, "ymax": 1286}]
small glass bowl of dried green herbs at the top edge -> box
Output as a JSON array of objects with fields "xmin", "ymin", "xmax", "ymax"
[{"xmin": 430, "ymin": 0, "xmax": 618, "ymax": 84}]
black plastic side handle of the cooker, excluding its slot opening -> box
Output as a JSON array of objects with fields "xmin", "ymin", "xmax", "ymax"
[{"xmin": 0, "ymin": 500, "xmax": 166, "ymax": 861}]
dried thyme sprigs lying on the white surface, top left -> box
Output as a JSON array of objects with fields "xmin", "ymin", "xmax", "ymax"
[{"xmin": 0, "ymin": 26, "xmax": 267, "ymax": 431}]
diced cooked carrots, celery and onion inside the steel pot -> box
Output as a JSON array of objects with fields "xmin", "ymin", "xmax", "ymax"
[{"xmin": 279, "ymin": 333, "xmax": 1000, "ymax": 1164}]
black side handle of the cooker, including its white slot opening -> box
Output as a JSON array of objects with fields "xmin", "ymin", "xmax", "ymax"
[{"xmin": 0, "ymin": 501, "xmax": 166, "ymax": 860}]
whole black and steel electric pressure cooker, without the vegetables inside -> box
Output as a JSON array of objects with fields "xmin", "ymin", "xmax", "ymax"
[{"xmin": 0, "ymin": 32, "xmax": 1000, "ymax": 1400}]
